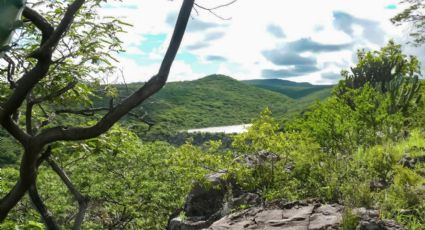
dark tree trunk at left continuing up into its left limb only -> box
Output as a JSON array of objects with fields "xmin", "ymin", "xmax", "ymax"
[{"xmin": 0, "ymin": 0, "xmax": 85, "ymax": 221}]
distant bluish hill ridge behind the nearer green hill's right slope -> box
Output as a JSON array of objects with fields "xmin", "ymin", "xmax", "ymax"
[{"xmin": 243, "ymin": 79, "xmax": 333, "ymax": 101}]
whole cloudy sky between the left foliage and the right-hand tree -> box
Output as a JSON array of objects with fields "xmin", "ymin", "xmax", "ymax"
[{"xmin": 99, "ymin": 0, "xmax": 425, "ymax": 84}]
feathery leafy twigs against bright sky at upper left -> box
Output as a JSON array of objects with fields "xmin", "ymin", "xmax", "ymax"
[{"xmin": 0, "ymin": 1, "xmax": 129, "ymax": 130}]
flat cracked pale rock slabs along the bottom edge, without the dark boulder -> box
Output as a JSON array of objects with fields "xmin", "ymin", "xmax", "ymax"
[{"xmin": 206, "ymin": 202, "xmax": 404, "ymax": 230}]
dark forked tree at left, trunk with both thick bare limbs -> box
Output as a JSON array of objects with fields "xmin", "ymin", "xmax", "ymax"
[{"xmin": 0, "ymin": 0, "xmax": 194, "ymax": 224}]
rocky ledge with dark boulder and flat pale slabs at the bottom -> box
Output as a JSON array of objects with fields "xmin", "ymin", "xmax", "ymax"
[{"xmin": 167, "ymin": 153, "xmax": 404, "ymax": 230}]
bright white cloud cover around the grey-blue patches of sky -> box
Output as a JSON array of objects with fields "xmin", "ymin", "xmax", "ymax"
[{"xmin": 102, "ymin": 0, "xmax": 423, "ymax": 84}]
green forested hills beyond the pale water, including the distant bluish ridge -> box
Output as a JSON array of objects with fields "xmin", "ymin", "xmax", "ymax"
[{"xmin": 103, "ymin": 75, "xmax": 330, "ymax": 133}]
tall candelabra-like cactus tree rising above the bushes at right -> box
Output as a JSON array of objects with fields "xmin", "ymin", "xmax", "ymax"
[{"xmin": 335, "ymin": 41, "xmax": 421, "ymax": 115}]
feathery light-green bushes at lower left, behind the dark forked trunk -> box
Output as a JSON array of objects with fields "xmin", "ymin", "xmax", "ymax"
[{"xmin": 0, "ymin": 127, "xmax": 221, "ymax": 229}]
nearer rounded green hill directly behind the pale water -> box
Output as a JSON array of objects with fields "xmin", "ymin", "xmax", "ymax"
[{"xmin": 112, "ymin": 75, "xmax": 294, "ymax": 130}]
